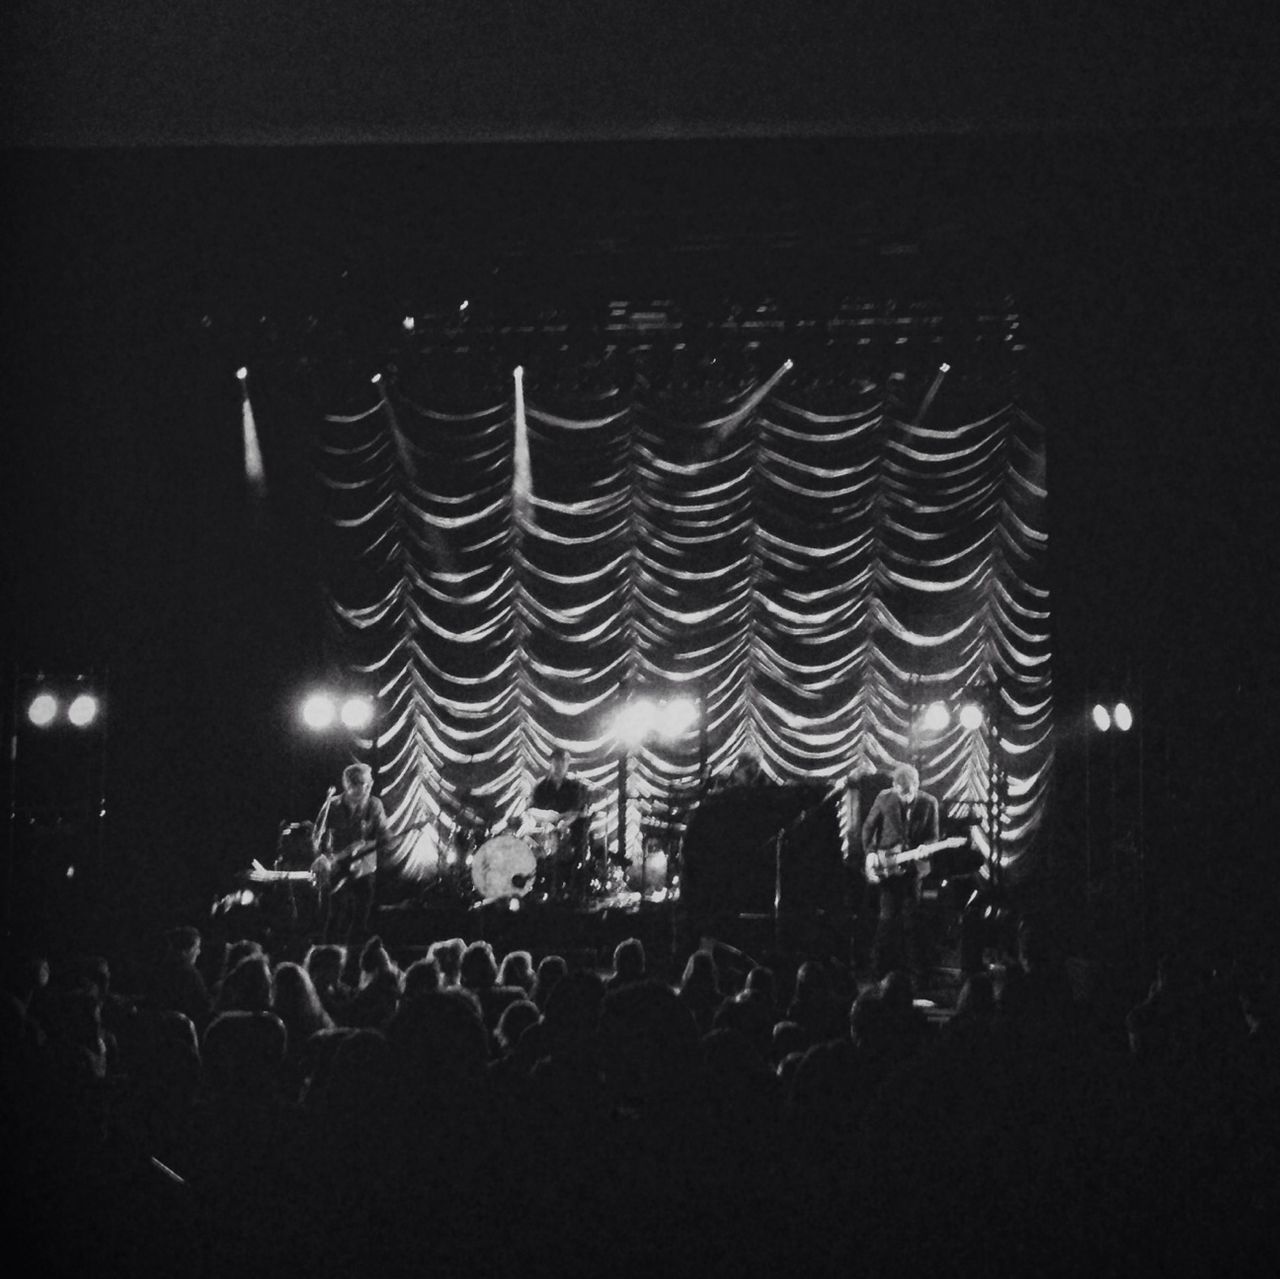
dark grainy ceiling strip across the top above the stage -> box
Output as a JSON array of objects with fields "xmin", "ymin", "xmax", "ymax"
[{"xmin": 3, "ymin": 0, "xmax": 1276, "ymax": 146}]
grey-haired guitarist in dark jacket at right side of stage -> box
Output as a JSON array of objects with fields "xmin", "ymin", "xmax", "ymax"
[{"xmin": 863, "ymin": 764, "xmax": 938, "ymax": 983}]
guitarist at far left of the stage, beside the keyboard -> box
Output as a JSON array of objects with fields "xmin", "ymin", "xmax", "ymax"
[{"xmin": 316, "ymin": 764, "xmax": 390, "ymax": 947}]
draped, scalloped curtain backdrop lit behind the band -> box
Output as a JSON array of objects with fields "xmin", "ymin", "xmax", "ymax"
[{"xmin": 246, "ymin": 315, "xmax": 1052, "ymax": 877}]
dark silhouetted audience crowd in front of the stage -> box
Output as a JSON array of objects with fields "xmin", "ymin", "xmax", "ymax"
[{"xmin": 3, "ymin": 927, "xmax": 1280, "ymax": 1275}]
